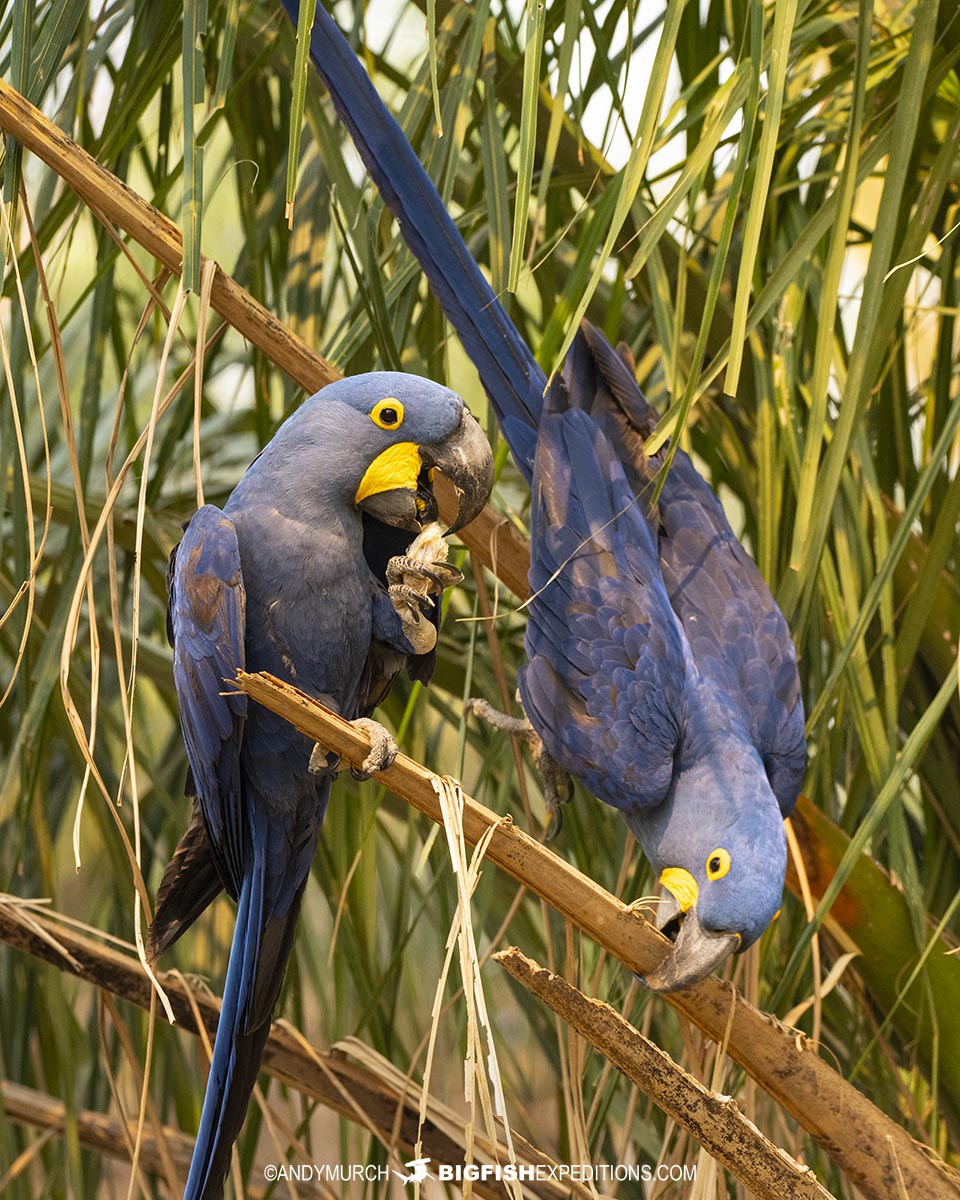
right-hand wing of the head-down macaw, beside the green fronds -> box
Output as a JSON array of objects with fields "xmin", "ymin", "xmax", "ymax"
[{"xmin": 584, "ymin": 326, "xmax": 806, "ymax": 816}]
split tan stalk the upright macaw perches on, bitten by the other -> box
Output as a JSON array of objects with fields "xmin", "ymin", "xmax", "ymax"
[{"xmin": 236, "ymin": 672, "xmax": 960, "ymax": 1200}]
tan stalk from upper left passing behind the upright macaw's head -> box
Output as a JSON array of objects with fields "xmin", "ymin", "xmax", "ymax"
[{"xmin": 0, "ymin": 79, "xmax": 529, "ymax": 594}]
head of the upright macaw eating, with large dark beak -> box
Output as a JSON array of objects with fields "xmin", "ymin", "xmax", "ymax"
[{"xmin": 275, "ymin": 371, "xmax": 493, "ymax": 533}]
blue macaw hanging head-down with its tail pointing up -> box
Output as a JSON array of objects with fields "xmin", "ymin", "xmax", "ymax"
[{"xmin": 283, "ymin": 0, "xmax": 806, "ymax": 990}]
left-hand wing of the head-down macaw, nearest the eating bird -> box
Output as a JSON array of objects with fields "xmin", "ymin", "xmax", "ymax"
[{"xmin": 520, "ymin": 376, "xmax": 688, "ymax": 810}]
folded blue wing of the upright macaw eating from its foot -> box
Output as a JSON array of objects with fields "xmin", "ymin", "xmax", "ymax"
[{"xmin": 168, "ymin": 504, "xmax": 247, "ymax": 900}]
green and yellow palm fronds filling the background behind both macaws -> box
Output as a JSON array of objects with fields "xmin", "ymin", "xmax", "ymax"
[{"xmin": 0, "ymin": 0, "xmax": 960, "ymax": 1200}]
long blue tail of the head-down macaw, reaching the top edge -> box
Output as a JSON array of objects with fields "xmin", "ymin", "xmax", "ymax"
[{"xmin": 283, "ymin": 0, "xmax": 546, "ymax": 476}]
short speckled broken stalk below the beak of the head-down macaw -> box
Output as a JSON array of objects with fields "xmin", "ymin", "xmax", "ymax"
[{"xmin": 493, "ymin": 946, "xmax": 830, "ymax": 1200}]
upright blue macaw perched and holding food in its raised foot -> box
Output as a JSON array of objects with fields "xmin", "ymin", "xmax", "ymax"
[{"xmin": 150, "ymin": 372, "xmax": 493, "ymax": 1200}]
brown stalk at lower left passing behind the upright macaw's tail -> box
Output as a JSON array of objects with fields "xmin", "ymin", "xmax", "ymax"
[{"xmin": 0, "ymin": 902, "xmax": 578, "ymax": 1200}]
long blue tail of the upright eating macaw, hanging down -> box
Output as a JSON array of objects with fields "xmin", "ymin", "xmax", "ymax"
[{"xmin": 184, "ymin": 866, "xmax": 300, "ymax": 1200}]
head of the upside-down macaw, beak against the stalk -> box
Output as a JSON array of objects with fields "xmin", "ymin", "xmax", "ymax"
[{"xmin": 630, "ymin": 743, "xmax": 787, "ymax": 991}]
